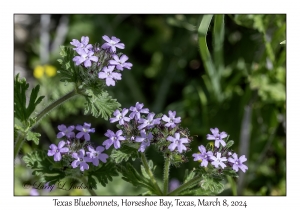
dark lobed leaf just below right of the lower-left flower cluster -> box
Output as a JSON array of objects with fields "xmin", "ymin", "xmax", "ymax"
[{"xmin": 88, "ymin": 162, "xmax": 118, "ymax": 189}]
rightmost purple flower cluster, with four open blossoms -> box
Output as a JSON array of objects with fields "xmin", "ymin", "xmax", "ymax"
[{"xmin": 193, "ymin": 128, "xmax": 248, "ymax": 173}]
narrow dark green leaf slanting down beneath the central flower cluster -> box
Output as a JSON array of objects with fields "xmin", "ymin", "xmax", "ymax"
[{"xmin": 118, "ymin": 163, "xmax": 157, "ymax": 194}]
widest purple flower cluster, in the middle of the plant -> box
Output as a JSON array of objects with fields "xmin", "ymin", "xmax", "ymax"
[{"xmin": 103, "ymin": 102, "xmax": 190, "ymax": 158}]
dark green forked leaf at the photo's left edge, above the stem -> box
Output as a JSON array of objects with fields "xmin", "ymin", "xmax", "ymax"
[{"xmin": 14, "ymin": 74, "xmax": 45, "ymax": 122}]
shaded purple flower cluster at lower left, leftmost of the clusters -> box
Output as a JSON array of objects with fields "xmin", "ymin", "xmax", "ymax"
[{"xmin": 48, "ymin": 123, "xmax": 108, "ymax": 171}]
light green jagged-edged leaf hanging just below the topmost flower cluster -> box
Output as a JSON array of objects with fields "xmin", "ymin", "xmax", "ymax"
[{"xmin": 84, "ymin": 89, "xmax": 121, "ymax": 120}]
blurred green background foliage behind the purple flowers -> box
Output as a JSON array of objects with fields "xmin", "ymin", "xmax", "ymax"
[{"xmin": 14, "ymin": 14, "xmax": 286, "ymax": 195}]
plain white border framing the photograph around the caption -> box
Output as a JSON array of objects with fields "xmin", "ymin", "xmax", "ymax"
[{"xmin": 4, "ymin": 0, "xmax": 300, "ymax": 210}]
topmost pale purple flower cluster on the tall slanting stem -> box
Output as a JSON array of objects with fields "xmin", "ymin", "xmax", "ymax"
[{"xmin": 70, "ymin": 35, "xmax": 132, "ymax": 86}]
